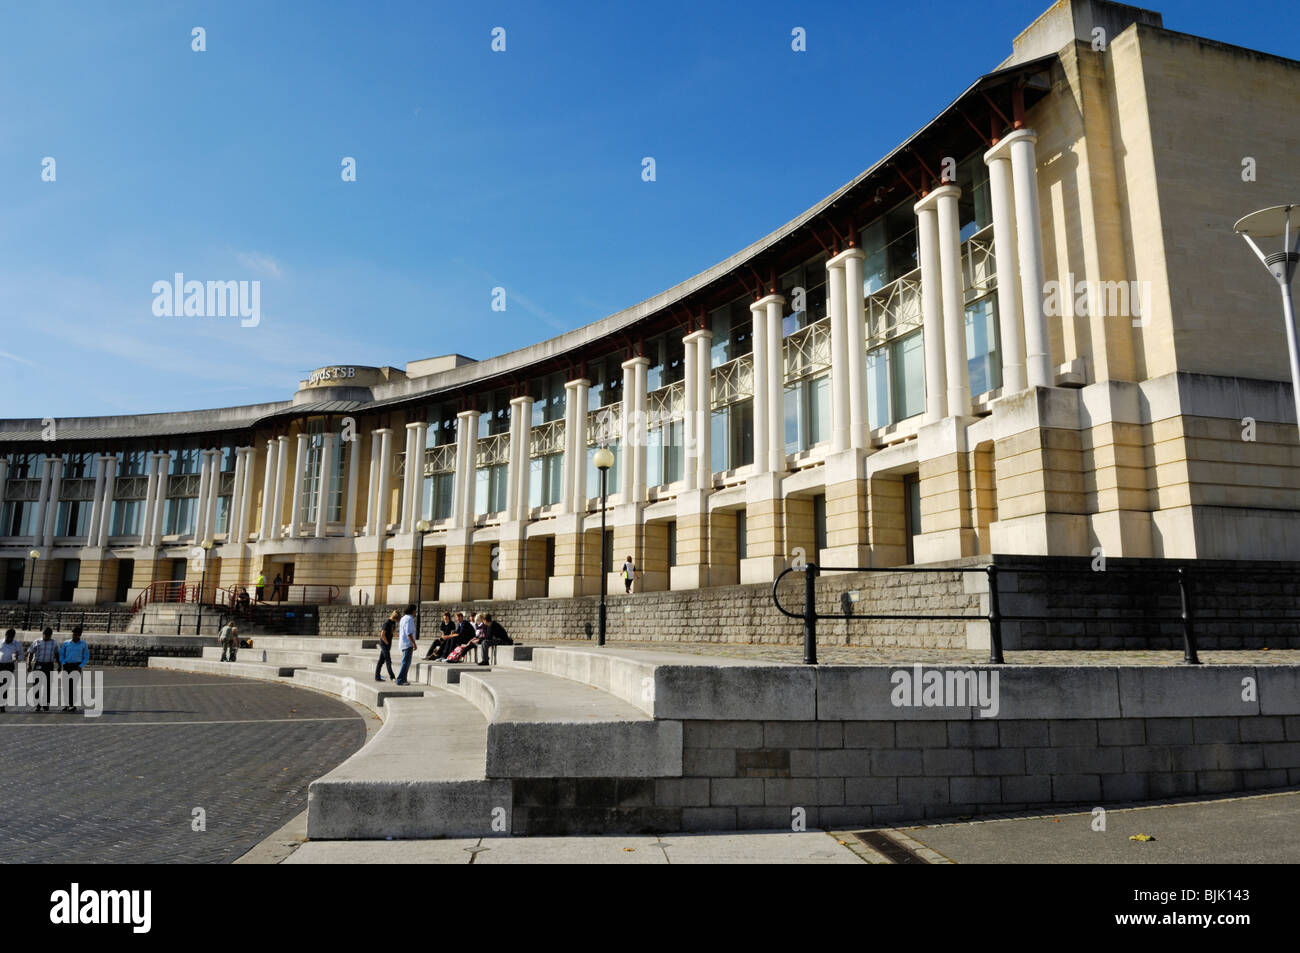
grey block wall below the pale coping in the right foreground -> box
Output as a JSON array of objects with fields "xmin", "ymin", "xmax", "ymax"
[{"xmin": 512, "ymin": 715, "xmax": 1300, "ymax": 835}]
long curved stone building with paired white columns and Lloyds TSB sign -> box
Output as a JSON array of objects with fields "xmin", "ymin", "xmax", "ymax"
[{"xmin": 0, "ymin": 0, "xmax": 1300, "ymax": 603}]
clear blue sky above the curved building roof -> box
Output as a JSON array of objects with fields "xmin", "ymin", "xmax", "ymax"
[{"xmin": 0, "ymin": 0, "xmax": 1300, "ymax": 417}]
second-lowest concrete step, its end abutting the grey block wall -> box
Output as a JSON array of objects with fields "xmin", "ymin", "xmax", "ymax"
[{"xmin": 446, "ymin": 667, "xmax": 683, "ymax": 777}]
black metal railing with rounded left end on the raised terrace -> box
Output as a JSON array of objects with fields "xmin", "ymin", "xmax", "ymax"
[{"xmin": 772, "ymin": 563, "xmax": 1300, "ymax": 666}]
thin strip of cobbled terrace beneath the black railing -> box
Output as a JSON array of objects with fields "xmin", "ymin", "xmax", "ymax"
[{"xmin": 524, "ymin": 640, "xmax": 1300, "ymax": 666}]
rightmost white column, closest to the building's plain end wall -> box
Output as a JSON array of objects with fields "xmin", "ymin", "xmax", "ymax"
[{"xmin": 1002, "ymin": 129, "xmax": 1056, "ymax": 387}]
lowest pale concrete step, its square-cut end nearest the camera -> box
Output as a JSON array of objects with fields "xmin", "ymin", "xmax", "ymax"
[{"xmin": 307, "ymin": 692, "xmax": 512, "ymax": 840}]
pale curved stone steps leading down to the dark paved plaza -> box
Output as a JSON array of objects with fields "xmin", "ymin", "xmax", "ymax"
[{"xmin": 150, "ymin": 636, "xmax": 717, "ymax": 840}]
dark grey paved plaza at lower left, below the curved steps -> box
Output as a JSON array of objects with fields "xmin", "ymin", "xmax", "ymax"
[{"xmin": 0, "ymin": 668, "xmax": 365, "ymax": 863}]
